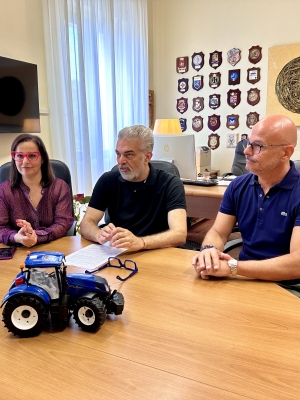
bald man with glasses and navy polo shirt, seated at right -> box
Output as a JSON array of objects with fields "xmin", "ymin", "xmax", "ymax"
[{"xmin": 192, "ymin": 115, "xmax": 300, "ymax": 297}]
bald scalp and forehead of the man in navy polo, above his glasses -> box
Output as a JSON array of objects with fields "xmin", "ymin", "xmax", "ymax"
[{"xmin": 251, "ymin": 115, "xmax": 297, "ymax": 147}]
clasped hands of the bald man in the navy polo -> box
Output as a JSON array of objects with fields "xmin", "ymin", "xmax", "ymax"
[{"xmin": 192, "ymin": 247, "xmax": 232, "ymax": 279}]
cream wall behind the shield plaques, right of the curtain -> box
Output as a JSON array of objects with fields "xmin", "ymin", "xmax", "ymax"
[{"xmin": 148, "ymin": 0, "xmax": 300, "ymax": 173}]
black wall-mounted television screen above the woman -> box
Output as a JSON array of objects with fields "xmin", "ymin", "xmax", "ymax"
[{"xmin": 0, "ymin": 56, "xmax": 40, "ymax": 133}]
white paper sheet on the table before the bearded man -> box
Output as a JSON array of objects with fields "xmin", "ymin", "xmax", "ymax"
[{"xmin": 66, "ymin": 243, "xmax": 127, "ymax": 271}]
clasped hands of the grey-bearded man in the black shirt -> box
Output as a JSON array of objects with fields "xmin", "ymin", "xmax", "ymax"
[{"xmin": 97, "ymin": 223, "xmax": 144, "ymax": 251}]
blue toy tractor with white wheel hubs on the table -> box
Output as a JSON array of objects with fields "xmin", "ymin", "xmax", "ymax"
[{"xmin": 0, "ymin": 251, "xmax": 124, "ymax": 337}]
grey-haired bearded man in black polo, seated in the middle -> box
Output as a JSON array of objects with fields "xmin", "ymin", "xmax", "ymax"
[{"xmin": 80, "ymin": 125, "xmax": 187, "ymax": 251}]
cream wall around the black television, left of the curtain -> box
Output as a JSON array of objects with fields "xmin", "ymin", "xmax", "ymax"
[{"xmin": 0, "ymin": 0, "xmax": 52, "ymax": 165}]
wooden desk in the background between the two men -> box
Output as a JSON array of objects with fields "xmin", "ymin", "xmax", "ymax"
[{"xmin": 184, "ymin": 185, "xmax": 227, "ymax": 219}]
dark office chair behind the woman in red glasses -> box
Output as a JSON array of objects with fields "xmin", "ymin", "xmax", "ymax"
[{"xmin": 0, "ymin": 160, "xmax": 76, "ymax": 236}]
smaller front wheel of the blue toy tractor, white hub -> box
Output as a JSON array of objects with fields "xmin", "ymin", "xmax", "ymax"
[{"xmin": 73, "ymin": 297, "xmax": 106, "ymax": 332}]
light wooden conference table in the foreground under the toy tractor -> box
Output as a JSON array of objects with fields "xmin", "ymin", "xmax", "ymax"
[{"xmin": 0, "ymin": 236, "xmax": 300, "ymax": 400}]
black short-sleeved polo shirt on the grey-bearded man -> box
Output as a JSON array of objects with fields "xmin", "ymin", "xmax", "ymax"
[{"xmin": 89, "ymin": 164, "xmax": 186, "ymax": 236}]
